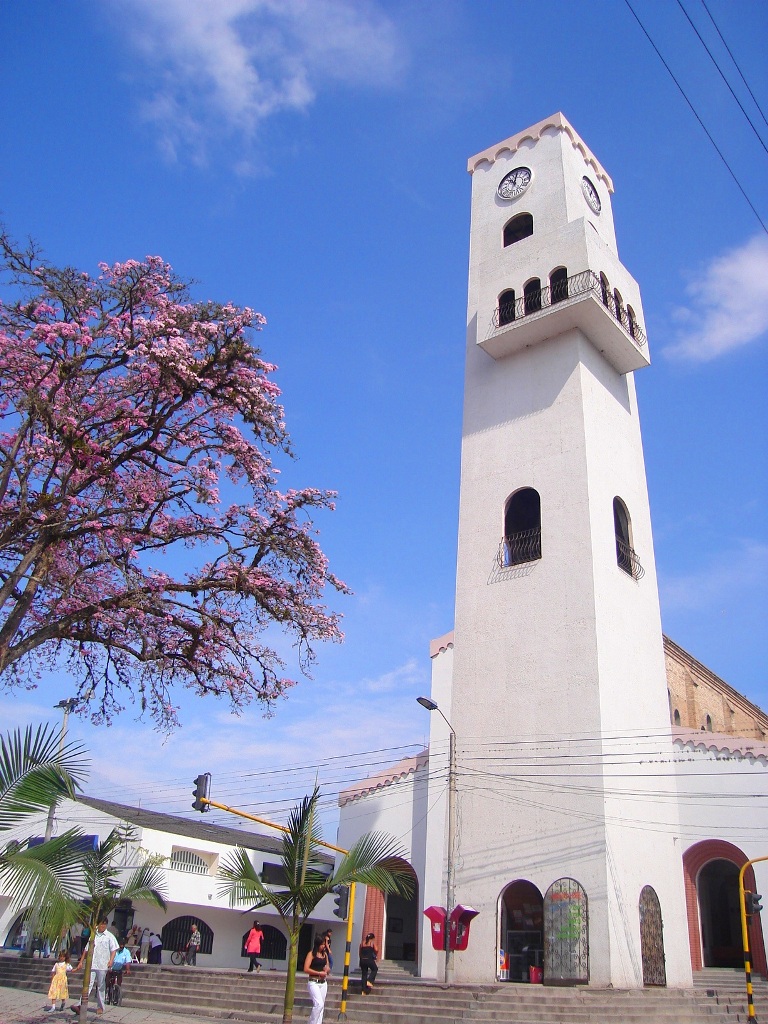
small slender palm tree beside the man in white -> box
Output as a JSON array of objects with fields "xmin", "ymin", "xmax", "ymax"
[{"xmin": 71, "ymin": 825, "xmax": 166, "ymax": 1021}]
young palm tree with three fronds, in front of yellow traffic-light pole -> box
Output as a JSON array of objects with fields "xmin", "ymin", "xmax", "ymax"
[{"xmin": 219, "ymin": 786, "xmax": 413, "ymax": 1024}]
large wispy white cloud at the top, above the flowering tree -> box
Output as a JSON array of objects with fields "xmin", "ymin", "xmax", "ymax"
[{"xmin": 117, "ymin": 0, "xmax": 402, "ymax": 159}]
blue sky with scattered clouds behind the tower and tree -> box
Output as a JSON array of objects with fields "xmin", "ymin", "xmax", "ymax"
[{"xmin": 0, "ymin": 0, "xmax": 768, "ymax": 831}]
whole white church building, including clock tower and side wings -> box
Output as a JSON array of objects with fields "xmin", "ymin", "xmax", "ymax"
[{"xmin": 338, "ymin": 114, "xmax": 768, "ymax": 988}]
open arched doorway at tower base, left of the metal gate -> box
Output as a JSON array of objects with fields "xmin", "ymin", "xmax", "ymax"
[{"xmin": 499, "ymin": 879, "xmax": 544, "ymax": 982}]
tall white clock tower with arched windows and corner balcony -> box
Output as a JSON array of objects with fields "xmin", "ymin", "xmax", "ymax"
[{"xmin": 425, "ymin": 114, "xmax": 691, "ymax": 988}]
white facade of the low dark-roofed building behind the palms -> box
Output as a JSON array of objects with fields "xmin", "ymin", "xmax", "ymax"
[{"xmin": 0, "ymin": 798, "xmax": 344, "ymax": 970}]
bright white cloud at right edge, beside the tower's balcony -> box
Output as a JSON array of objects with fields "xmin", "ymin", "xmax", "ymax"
[{"xmin": 666, "ymin": 236, "xmax": 768, "ymax": 362}]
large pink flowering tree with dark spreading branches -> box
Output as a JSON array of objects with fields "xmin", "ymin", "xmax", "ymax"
[{"xmin": 0, "ymin": 233, "xmax": 346, "ymax": 728}]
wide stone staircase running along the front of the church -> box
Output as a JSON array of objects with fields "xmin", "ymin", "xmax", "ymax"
[{"xmin": 0, "ymin": 955, "xmax": 768, "ymax": 1024}]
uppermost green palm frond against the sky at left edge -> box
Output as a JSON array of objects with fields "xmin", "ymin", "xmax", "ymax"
[{"xmin": 0, "ymin": 725, "xmax": 87, "ymax": 831}]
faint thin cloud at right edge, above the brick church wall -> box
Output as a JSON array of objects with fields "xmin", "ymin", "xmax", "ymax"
[{"xmin": 659, "ymin": 541, "xmax": 768, "ymax": 612}]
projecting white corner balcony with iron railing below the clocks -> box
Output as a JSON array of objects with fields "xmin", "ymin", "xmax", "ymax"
[{"xmin": 478, "ymin": 270, "xmax": 650, "ymax": 374}]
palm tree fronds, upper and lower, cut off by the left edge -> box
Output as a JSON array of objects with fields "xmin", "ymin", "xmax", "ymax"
[{"xmin": 0, "ymin": 725, "xmax": 87, "ymax": 938}]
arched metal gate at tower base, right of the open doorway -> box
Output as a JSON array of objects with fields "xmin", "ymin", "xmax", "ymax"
[{"xmin": 544, "ymin": 879, "xmax": 590, "ymax": 985}]
